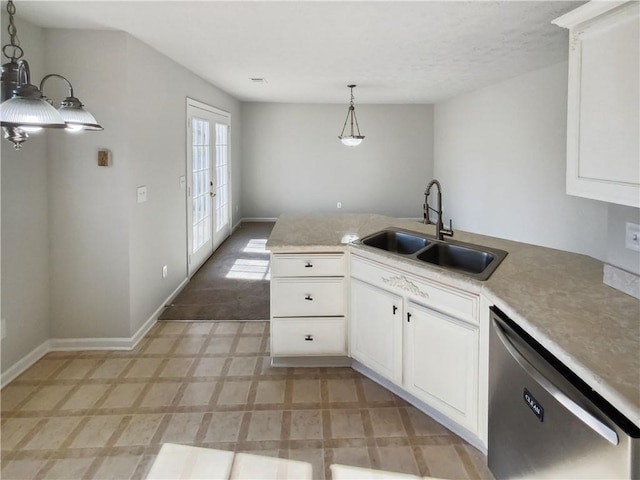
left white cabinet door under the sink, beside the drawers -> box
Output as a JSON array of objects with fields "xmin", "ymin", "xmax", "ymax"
[{"xmin": 350, "ymin": 279, "xmax": 402, "ymax": 384}]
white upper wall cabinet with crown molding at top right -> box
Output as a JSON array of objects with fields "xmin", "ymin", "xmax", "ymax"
[{"xmin": 553, "ymin": 1, "xmax": 640, "ymax": 208}]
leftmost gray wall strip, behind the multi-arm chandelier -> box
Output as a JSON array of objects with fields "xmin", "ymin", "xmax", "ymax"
[{"xmin": 0, "ymin": 15, "xmax": 49, "ymax": 372}]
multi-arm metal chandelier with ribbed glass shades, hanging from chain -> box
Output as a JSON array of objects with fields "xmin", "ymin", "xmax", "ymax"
[{"xmin": 0, "ymin": 0, "xmax": 103, "ymax": 150}]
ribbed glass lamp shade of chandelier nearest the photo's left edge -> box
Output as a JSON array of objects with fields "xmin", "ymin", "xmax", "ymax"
[{"xmin": 0, "ymin": 96, "xmax": 66, "ymax": 128}]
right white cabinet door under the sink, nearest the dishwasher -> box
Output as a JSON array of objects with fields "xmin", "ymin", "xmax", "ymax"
[{"xmin": 404, "ymin": 302, "xmax": 478, "ymax": 433}]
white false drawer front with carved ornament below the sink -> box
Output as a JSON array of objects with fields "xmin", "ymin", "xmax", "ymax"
[{"xmin": 351, "ymin": 255, "xmax": 480, "ymax": 323}]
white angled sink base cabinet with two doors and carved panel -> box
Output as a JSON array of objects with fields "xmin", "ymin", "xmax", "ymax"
[{"xmin": 349, "ymin": 252, "xmax": 480, "ymax": 435}]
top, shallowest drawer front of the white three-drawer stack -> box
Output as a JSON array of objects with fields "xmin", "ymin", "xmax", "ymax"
[{"xmin": 271, "ymin": 253, "xmax": 346, "ymax": 277}]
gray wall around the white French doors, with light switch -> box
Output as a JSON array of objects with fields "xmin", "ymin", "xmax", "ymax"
[{"xmin": 126, "ymin": 36, "xmax": 241, "ymax": 333}]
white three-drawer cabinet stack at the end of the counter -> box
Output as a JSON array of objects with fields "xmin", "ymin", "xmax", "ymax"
[{"xmin": 271, "ymin": 253, "xmax": 347, "ymax": 357}]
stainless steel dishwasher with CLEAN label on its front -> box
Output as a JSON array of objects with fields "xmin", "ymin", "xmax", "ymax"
[{"xmin": 488, "ymin": 307, "xmax": 640, "ymax": 479}]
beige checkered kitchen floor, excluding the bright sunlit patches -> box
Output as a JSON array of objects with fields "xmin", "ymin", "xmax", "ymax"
[{"xmin": 0, "ymin": 322, "xmax": 492, "ymax": 479}]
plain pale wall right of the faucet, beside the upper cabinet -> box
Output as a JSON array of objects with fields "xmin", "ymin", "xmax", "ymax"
[{"xmin": 434, "ymin": 63, "xmax": 608, "ymax": 260}]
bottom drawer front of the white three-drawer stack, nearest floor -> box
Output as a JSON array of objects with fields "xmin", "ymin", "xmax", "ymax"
[{"xmin": 271, "ymin": 318, "xmax": 347, "ymax": 356}]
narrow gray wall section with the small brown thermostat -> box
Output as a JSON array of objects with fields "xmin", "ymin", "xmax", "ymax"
[{"xmin": 46, "ymin": 30, "xmax": 131, "ymax": 338}]
